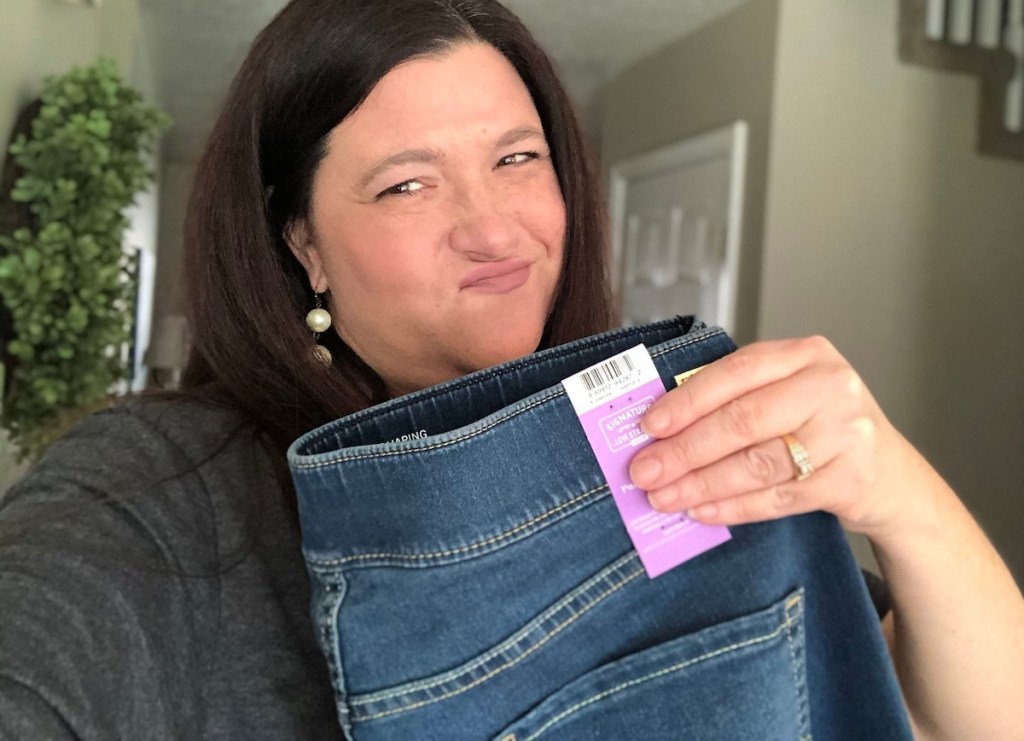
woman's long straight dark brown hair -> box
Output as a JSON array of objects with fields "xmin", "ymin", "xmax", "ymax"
[{"xmin": 183, "ymin": 0, "xmax": 610, "ymax": 446}]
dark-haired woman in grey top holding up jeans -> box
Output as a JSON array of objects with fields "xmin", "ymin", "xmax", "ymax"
[{"xmin": 0, "ymin": 0, "xmax": 1024, "ymax": 738}]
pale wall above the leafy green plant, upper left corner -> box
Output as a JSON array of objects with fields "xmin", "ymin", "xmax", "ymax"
[{"xmin": 0, "ymin": 0, "xmax": 153, "ymax": 492}]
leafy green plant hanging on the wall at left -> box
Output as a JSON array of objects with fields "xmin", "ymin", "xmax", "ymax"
[{"xmin": 0, "ymin": 59, "xmax": 170, "ymax": 457}]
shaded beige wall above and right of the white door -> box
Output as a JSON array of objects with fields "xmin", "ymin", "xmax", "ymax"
[{"xmin": 601, "ymin": 0, "xmax": 778, "ymax": 342}]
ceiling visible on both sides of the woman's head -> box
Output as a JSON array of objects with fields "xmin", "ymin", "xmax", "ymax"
[{"xmin": 139, "ymin": 0, "xmax": 749, "ymax": 162}]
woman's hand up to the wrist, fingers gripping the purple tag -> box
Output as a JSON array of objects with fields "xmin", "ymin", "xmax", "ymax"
[{"xmin": 630, "ymin": 337, "xmax": 929, "ymax": 536}]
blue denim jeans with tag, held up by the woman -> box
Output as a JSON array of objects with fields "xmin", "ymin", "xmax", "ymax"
[{"xmin": 289, "ymin": 317, "xmax": 910, "ymax": 741}]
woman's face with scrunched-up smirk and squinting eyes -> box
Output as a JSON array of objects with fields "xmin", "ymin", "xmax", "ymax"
[{"xmin": 291, "ymin": 43, "xmax": 565, "ymax": 394}]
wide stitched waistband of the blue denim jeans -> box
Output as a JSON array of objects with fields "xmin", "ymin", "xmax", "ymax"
[{"xmin": 288, "ymin": 316, "xmax": 735, "ymax": 568}]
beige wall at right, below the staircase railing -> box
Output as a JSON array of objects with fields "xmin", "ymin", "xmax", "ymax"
[{"xmin": 760, "ymin": 0, "xmax": 1024, "ymax": 581}]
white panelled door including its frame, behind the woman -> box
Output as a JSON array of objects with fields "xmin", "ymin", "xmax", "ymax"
[{"xmin": 611, "ymin": 122, "xmax": 746, "ymax": 332}]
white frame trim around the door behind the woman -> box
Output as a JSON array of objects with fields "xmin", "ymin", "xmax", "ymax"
[{"xmin": 608, "ymin": 121, "xmax": 749, "ymax": 332}]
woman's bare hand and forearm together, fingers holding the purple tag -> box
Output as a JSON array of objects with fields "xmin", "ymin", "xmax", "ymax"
[{"xmin": 630, "ymin": 338, "xmax": 1024, "ymax": 739}]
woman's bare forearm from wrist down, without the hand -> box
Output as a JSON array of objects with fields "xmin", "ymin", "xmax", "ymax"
[{"xmin": 868, "ymin": 433, "xmax": 1024, "ymax": 739}]
